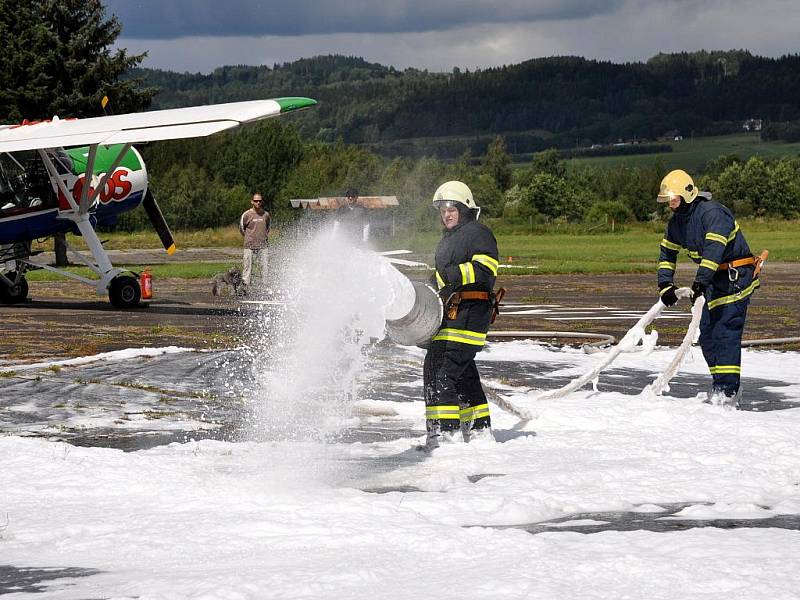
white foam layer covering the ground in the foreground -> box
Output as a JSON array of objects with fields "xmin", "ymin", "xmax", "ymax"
[{"xmin": 0, "ymin": 342, "xmax": 800, "ymax": 600}]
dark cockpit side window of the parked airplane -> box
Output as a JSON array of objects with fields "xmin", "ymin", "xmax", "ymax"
[{"xmin": 0, "ymin": 152, "xmax": 58, "ymax": 218}]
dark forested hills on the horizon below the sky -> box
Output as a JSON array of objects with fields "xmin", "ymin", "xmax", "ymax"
[{"xmin": 133, "ymin": 51, "xmax": 800, "ymax": 156}]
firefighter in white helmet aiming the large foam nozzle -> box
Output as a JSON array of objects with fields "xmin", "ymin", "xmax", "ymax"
[{"xmin": 423, "ymin": 181, "xmax": 498, "ymax": 449}]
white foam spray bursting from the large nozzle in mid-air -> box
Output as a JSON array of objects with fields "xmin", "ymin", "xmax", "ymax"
[{"xmin": 251, "ymin": 231, "xmax": 413, "ymax": 441}]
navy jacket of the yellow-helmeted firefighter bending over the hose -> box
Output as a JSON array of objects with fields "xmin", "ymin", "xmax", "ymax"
[{"xmin": 658, "ymin": 195, "xmax": 752, "ymax": 287}]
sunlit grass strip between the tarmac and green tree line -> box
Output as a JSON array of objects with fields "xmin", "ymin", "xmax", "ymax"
[{"xmin": 30, "ymin": 219, "xmax": 800, "ymax": 281}]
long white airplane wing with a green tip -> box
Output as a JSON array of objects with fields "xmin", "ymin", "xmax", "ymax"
[{"xmin": 0, "ymin": 97, "xmax": 317, "ymax": 152}]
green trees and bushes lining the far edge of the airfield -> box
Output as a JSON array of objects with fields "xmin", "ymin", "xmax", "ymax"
[{"xmin": 115, "ymin": 126, "xmax": 800, "ymax": 231}]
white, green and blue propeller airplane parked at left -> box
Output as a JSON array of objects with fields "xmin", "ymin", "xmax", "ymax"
[{"xmin": 0, "ymin": 97, "xmax": 317, "ymax": 308}]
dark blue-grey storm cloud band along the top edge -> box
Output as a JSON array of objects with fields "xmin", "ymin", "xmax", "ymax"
[{"xmin": 106, "ymin": 0, "xmax": 622, "ymax": 39}]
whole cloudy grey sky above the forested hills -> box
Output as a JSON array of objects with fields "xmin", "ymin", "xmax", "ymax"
[{"xmin": 109, "ymin": 0, "xmax": 800, "ymax": 72}]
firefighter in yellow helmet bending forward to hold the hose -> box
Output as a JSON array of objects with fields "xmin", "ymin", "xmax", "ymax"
[{"xmin": 658, "ymin": 169, "xmax": 766, "ymax": 407}]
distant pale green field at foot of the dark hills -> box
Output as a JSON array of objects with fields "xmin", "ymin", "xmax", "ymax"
[{"xmin": 514, "ymin": 133, "xmax": 800, "ymax": 172}]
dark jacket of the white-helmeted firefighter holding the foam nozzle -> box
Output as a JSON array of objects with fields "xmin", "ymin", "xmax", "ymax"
[{"xmin": 433, "ymin": 220, "xmax": 499, "ymax": 346}]
